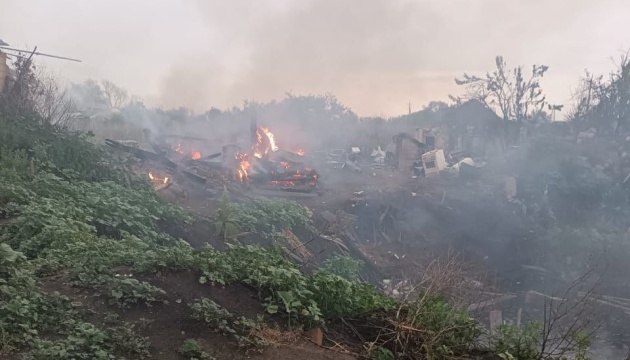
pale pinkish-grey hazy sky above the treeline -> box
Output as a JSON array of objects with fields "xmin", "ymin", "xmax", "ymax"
[{"xmin": 0, "ymin": 0, "xmax": 630, "ymax": 116}]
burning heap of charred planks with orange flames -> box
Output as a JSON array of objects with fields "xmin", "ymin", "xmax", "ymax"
[{"xmin": 106, "ymin": 125, "xmax": 319, "ymax": 197}]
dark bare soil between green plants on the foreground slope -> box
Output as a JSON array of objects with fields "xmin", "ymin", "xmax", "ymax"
[{"xmin": 43, "ymin": 271, "xmax": 354, "ymax": 360}]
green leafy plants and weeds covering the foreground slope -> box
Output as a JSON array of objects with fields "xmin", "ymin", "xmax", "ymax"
[{"xmin": 0, "ymin": 56, "xmax": 604, "ymax": 360}]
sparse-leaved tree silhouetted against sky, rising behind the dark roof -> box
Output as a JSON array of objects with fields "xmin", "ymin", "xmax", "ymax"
[{"xmin": 451, "ymin": 56, "xmax": 549, "ymax": 124}]
